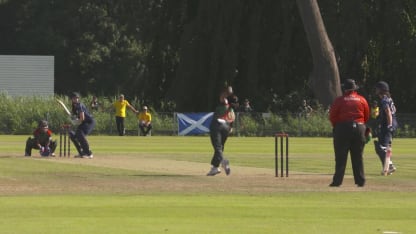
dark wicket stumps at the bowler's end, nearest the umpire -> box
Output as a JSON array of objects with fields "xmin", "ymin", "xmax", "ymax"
[{"xmin": 274, "ymin": 133, "xmax": 289, "ymax": 177}]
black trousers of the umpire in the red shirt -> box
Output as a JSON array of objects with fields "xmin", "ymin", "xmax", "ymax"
[{"xmin": 332, "ymin": 122, "xmax": 366, "ymax": 186}]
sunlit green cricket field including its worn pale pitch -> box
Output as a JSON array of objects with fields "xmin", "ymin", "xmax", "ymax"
[{"xmin": 0, "ymin": 136, "xmax": 416, "ymax": 233}]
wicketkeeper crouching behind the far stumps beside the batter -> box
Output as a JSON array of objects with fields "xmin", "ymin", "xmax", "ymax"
[{"xmin": 25, "ymin": 120, "xmax": 57, "ymax": 157}]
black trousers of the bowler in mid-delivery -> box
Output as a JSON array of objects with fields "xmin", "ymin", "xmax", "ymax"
[{"xmin": 209, "ymin": 119, "xmax": 231, "ymax": 167}]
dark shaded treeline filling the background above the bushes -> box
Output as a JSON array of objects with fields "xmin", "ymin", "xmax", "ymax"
[{"xmin": 0, "ymin": 0, "xmax": 416, "ymax": 112}]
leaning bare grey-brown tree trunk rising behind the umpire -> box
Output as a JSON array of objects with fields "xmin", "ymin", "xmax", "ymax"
[{"xmin": 296, "ymin": 0, "xmax": 341, "ymax": 107}]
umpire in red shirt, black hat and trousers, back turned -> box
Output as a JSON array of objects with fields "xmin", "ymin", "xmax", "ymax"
[{"xmin": 329, "ymin": 79, "xmax": 370, "ymax": 187}]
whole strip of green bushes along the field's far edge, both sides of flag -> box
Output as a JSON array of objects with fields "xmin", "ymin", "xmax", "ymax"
[{"xmin": 0, "ymin": 95, "xmax": 416, "ymax": 137}]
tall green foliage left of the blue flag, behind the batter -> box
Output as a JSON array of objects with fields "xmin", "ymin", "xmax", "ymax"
[{"xmin": 0, "ymin": 94, "xmax": 177, "ymax": 135}]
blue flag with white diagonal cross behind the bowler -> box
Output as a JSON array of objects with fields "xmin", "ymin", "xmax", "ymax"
[{"xmin": 177, "ymin": 112, "xmax": 214, "ymax": 136}]
